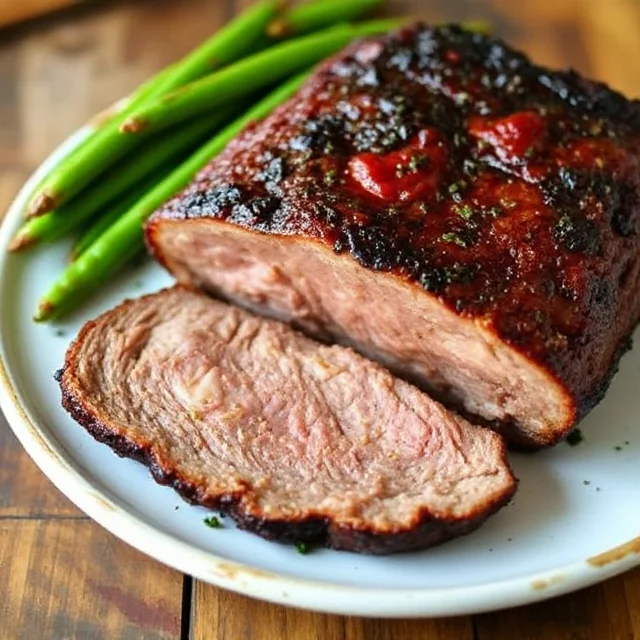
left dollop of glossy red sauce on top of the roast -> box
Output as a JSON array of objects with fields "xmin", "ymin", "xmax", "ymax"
[{"xmin": 347, "ymin": 129, "xmax": 447, "ymax": 205}]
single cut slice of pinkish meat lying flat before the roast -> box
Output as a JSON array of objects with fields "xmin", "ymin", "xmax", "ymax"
[{"xmin": 59, "ymin": 288, "xmax": 516, "ymax": 553}]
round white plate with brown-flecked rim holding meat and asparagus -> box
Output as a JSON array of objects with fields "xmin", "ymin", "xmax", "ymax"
[{"xmin": 0, "ymin": 127, "xmax": 640, "ymax": 617}]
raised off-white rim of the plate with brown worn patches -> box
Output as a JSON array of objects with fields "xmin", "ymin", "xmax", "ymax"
[{"xmin": 0, "ymin": 125, "xmax": 640, "ymax": 618}]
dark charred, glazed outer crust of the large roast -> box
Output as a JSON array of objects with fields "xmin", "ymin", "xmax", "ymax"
[{"xmin": 147, "ymin": 25, "xmax": 640, "ymax": 444}]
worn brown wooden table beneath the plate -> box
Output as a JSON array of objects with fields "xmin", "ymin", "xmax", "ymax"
[{"xmin": 0, "ymin": 0, "xmax": 640, "ymax": 640}]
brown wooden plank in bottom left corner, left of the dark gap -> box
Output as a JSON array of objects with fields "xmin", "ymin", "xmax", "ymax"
[{"xmin": 0, "ymin": 519, "xmax": 182, "ymax": 640}]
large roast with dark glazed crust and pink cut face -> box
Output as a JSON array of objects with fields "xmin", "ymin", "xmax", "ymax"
[{"xmin": 147, "ymin": 26, "xmax": 640, "ymax": 446}]
